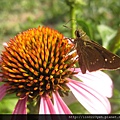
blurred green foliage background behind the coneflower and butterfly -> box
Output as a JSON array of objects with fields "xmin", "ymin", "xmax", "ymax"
[{"xmin": 0, "ymin": 0, "xmax": 120, "ymax": 113}]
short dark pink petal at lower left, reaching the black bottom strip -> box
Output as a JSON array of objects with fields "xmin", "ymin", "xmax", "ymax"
[{"xmin": 13, "ymin": 96, "xmax": 27, "ymax": 114}]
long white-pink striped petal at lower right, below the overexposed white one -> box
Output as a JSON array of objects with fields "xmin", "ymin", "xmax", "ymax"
[{"xmin": 67, "ymin": 79, "xmax": 111, "ymax": 114}]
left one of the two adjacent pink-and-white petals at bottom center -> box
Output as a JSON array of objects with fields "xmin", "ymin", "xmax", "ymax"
[{"xmin": 39, "ymin": 95, "xmax": 56, "ymax": 114}]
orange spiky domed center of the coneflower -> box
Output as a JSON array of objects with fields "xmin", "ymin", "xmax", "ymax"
[{"xmin": 2, "ymin": 27, "xmax": 76, "ymax": 99}]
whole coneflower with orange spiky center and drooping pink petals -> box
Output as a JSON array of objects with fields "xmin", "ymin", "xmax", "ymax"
[{"xmin": 0, "ymin": 27, "xmax": 112, "ymax": 114}]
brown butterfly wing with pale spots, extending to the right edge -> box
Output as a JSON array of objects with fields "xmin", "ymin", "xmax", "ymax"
[{"xmin": 81, "ymin": 41, "xmax": 120, "ymax": 72}]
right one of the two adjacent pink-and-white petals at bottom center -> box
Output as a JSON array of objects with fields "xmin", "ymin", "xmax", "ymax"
[{"xmin": 53, "ymin": 92, "xmax": 72, "ymax": 114}]
